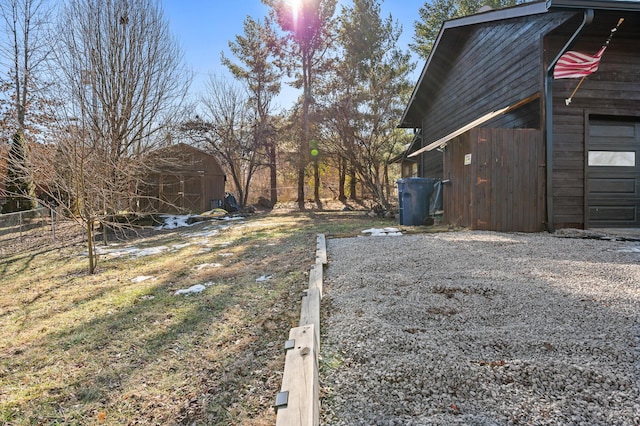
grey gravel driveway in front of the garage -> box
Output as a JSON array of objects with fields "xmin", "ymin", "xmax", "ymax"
[{"xmin": 320, "ymin": 232, "xmax": 640, "ymax": 426}]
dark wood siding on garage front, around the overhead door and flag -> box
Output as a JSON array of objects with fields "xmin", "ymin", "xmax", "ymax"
[{"xmin": 546, "ymin": 11, "xmax": 640, "ymax": 228}]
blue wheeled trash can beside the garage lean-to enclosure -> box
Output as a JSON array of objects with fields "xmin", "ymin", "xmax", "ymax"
[{"xmin": 396, "ymin": 177, "xmax": 438, "ymax": 226}]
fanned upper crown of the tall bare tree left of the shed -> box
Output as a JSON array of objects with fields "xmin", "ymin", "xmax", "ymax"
[{"xmin": 58, "ymin": 0, "xmax": 188, "ymax": 162}]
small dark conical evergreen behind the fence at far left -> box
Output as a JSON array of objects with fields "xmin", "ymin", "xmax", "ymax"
[{"xmin": 2, "ymin": 130, "xmax": 38, "ymax": 213}]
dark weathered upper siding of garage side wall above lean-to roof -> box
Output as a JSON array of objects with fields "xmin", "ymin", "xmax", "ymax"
[{"xmin": 422, "ymin": 13, "xmax": 572, "ymax": 149}]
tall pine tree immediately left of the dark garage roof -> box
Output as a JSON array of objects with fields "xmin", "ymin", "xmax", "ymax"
[{"xmin": 323, "ymin": 0, "xmax": 414, "ymax": 208}]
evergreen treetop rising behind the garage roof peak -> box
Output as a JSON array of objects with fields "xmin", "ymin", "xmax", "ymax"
[{"xmin": 409, "ymin": 0, "xmax": 526, "ymax": 60}]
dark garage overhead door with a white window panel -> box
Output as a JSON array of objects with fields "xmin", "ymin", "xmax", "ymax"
[{"xmin": 587, "ymin": 117, "xmax": 640, "ymax": 228}]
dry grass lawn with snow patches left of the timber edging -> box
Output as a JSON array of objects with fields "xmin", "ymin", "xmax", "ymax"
[{"xmin": 0, "ymin": 205, "xmax": 395, "ymax": 425}]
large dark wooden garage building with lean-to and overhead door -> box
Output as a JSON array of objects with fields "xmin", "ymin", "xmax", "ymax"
[{"xmin": 400, "ymin": 0, "xmax": 640, "ymax": 232}]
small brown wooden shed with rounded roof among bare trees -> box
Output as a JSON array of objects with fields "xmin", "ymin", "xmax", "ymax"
[{"xmin": 144, "ymin": 143, "xmax": 226, "ymax": 213}]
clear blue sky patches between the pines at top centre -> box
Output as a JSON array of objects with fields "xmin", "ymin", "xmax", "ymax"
[{"xmin": 162, "ymin": 0, "xmax": 425, "ymax": 108}]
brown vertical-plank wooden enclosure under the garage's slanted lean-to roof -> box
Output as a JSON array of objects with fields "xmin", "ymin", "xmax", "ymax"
[{"xmin": 444, "ymin": 128, "xmax": 545, "ymax": 232}]
